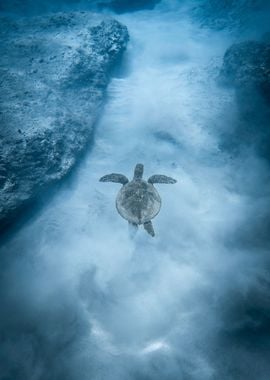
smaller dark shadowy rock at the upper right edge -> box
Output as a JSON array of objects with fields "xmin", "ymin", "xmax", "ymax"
[{"xmin": 220, "ymin": 41, "xmax": 270, "ymax": 161}]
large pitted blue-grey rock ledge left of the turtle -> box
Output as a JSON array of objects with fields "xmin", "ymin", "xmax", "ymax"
[{"xmin": 0, "ymin": 12, "xmax": 128, "ymax": 228}]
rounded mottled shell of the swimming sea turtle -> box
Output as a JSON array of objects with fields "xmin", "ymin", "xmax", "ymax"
[{"xmin": 116, "ymin": 180, "xmax": 161, "ymax": 224}]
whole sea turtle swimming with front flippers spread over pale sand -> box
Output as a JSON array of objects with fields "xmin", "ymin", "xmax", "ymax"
[{"xmin": 100, "ymin": 164, "xmax": 176, "ymax": 236}]
